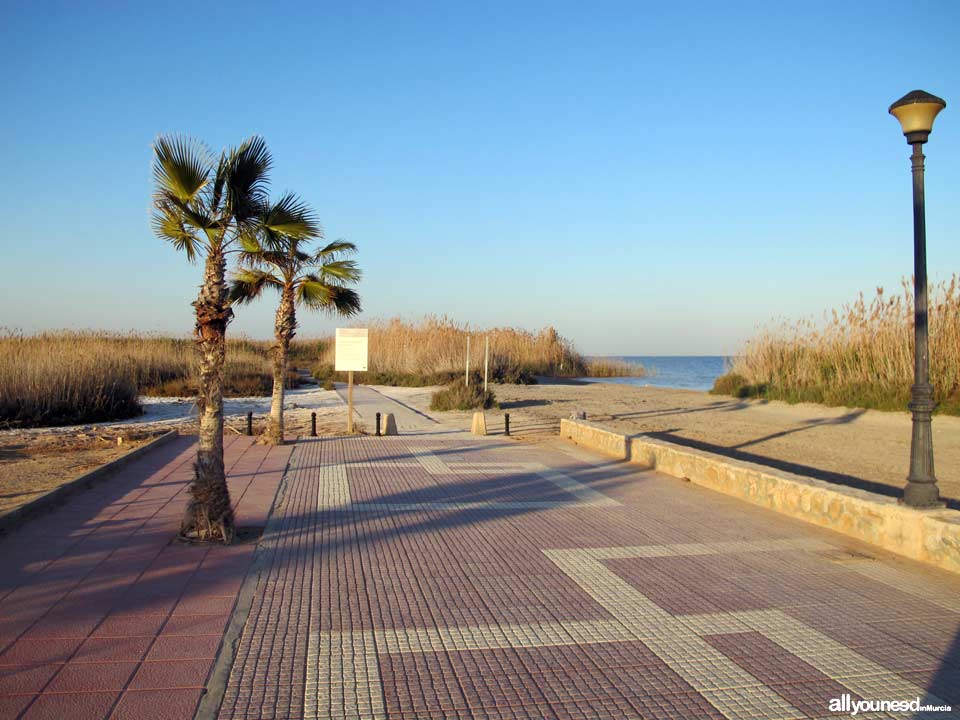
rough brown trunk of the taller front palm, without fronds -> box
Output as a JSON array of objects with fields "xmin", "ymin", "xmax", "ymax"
[{"xmin": 180, "ymin": 251, "xmax": 234, "ymax": 543}]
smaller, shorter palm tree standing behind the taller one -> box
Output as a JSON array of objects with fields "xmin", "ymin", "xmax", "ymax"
[{"xmin": 230, "ymin": 194, "xmax": 360, "ymax": 444}]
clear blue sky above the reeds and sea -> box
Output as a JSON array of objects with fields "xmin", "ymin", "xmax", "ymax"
[{"xmin": 0, "ymin": 0, "xmax": 960, "ymax": 354}]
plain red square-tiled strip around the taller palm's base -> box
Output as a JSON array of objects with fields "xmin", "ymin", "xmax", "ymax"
[{"xmin": 0, "ymin": 436, "xmax": 291, "ymax": 720}]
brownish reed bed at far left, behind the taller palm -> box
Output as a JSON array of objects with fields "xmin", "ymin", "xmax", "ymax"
[{"xmin": 0, "ymin": 331, "xmax": 316, "ymax": 427}]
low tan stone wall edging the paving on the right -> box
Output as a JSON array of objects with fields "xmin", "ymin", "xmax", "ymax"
[{"xmin": 560, "ymin": 420, "xmax": 960, "ymax": 573}]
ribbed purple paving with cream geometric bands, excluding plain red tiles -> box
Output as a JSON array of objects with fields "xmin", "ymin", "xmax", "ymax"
[{"xmin": 219, "ymin": 388, "xmax": 960, "ymax": 720}]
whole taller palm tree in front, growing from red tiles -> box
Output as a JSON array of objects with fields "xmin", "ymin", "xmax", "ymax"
[{"xmin": 153, "ymin": 136, "xmax": 272, "ymax": 543}]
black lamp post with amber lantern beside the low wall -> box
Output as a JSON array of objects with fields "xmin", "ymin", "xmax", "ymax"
[{"xmin": 890, "ymin": 90, "xmax": 947, "ymax": 508}]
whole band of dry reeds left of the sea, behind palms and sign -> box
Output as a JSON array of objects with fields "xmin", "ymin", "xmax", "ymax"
[{"xmin": 0, "ymin": 317, "xmax": 624, "ymax": 427}]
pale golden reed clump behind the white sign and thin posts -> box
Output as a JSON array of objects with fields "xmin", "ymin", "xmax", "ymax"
[{"xmin": 318, "ymin": 316, "xmax": 587, "ymax": 385}]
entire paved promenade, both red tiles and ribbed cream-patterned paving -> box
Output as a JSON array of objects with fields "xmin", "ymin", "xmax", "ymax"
[{"xmin": 0, "ymin": 388, "xmax": 960, "ymax": 720}]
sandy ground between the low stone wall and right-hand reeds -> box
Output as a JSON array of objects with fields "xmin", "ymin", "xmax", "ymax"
[{"xmin": 411, "ymin": 383, "xmax": 960, "ymax": 507}]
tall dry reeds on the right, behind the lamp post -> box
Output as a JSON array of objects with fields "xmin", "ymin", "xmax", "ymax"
[{"xmin": 714, "ymin": 275, "xmax": 960, "ymax": 415}]
